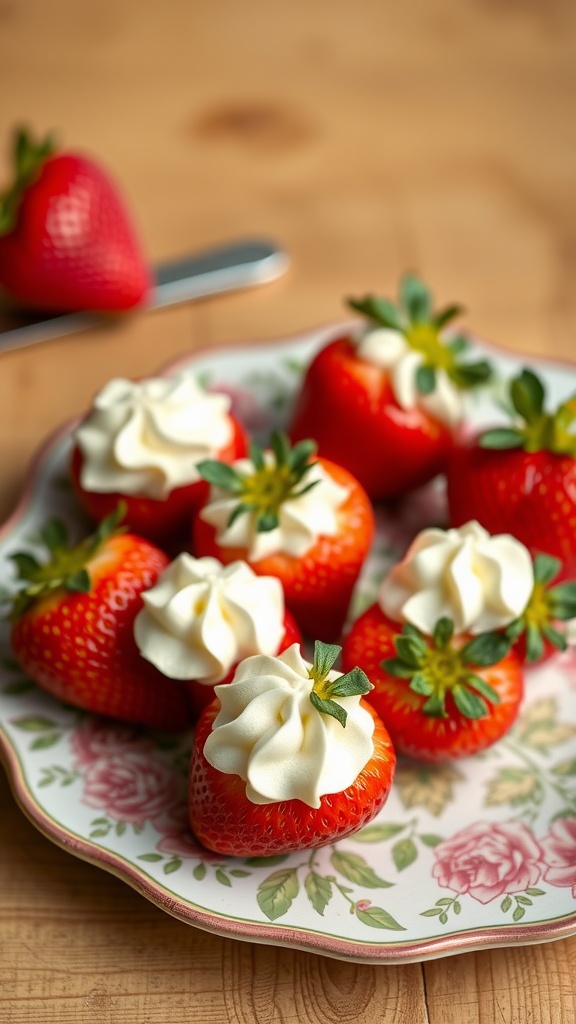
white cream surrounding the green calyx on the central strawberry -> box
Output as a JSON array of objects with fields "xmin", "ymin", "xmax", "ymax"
[{"xmin": 200, "ymin": 453, "xmax": 349, "ymax": 562}]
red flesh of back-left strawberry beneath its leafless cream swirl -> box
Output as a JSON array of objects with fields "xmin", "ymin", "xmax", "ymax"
[{"xmin": 71, "ymin": 416, "xmax": 248, "ymax": 550}]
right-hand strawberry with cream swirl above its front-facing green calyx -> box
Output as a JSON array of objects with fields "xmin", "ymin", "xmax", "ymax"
[{"xmin": 342, "ymin": 521, "xmax": 534, "ymax": 761}]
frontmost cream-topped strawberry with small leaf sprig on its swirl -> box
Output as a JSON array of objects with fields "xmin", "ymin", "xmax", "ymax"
[{"xmin": 189, "ymin": 643, "xmax": 396, "ymax": 857}]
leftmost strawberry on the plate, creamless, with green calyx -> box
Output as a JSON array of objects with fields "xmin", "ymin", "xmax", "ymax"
[{"xmin": 5, "ymin": 509, "xmax": 190, "ymax": 729}]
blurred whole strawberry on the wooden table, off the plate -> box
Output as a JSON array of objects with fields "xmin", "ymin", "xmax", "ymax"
[{"xmin": 0, "ymin": 130, "xmax": 151, "ymax": 312}]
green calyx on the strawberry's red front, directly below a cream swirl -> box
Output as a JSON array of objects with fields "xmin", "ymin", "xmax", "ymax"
[{"xmin": 381, "ymin": 617, "xmax": 511, "ymax": 719}]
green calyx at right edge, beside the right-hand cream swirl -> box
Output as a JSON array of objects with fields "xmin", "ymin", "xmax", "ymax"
[{"xmin": 505, "ymin": 555, "xmax": 576, "ymax": 664}]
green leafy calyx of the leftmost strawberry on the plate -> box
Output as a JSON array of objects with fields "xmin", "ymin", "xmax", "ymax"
[{"xmin": 3, "ymin": 503, "xmax": 126, "ymax": 622}]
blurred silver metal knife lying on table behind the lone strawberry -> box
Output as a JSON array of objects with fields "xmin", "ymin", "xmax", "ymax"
[{"xmin": 0, "ymin": 239, "xmax": 290, "ymax": 352}]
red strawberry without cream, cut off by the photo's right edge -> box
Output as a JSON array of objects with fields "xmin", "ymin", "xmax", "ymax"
[{"xmin": 448, "ymin": 370, "xmax": 576, "ymax": 579}]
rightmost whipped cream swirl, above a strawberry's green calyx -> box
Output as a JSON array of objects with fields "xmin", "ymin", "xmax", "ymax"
[{"xmin": 378, "ymin": 520, "xmax": 534, "ymax": 636}]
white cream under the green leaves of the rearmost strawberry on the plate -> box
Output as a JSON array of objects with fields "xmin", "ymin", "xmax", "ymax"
[{"xmin": 357, "ymin": 328, "xmax": 464, "ymax": 427}]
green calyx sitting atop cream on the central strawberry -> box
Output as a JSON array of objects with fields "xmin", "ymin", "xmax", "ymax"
[{"xmin": 196, "ymin": 430, "xmax": 320, "ymax": 534}]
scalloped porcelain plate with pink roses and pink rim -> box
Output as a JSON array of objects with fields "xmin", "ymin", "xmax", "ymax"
[{"xmin": 0, "ymin": 325, "xmax": 576, "ymax": 964}]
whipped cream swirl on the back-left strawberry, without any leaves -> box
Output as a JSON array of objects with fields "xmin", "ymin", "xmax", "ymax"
[{"xmin": 75, "ymin": 373, "xmax": 233, "ymax": 500}]
